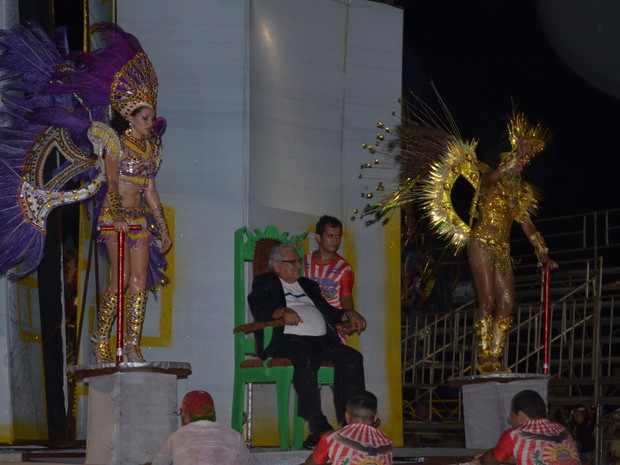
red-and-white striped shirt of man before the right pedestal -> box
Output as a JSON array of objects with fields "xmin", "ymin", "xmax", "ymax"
[{"xmin": 493, "ymin": 418, "xmax": 581, "ymax": 465}]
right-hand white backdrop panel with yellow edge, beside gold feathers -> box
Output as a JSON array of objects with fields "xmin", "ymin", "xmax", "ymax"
[{"xmin": 342, "ymin": 2, "xmax": 402, "ymax": 438}]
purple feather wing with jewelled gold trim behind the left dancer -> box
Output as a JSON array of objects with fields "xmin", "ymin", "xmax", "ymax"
[{"xmin": 0, "ymin": 24, "xmax": 98, "ymax": 278}]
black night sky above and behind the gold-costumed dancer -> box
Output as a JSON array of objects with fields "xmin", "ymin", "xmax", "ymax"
[{"xmin": 396, "ymin": 0, "xmax": 620, "ymax": 217}]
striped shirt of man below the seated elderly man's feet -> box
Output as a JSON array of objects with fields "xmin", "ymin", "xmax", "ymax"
[{"xmin": 312, "ymin": 423, "xmax": 392, "ymax": 465}]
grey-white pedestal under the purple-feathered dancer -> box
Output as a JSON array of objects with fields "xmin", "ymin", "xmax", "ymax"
[{"xmin": 73, "ymin": 362, "xmax": 191, "ymax": 465}]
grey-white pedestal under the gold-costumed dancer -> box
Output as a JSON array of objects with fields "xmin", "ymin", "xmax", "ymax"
[{"xmin": 452, "ymin": 374, "xmax": 549, "ymax": 449}]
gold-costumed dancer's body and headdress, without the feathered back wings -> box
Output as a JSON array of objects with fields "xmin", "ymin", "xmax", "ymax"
[{"xmin": 467, "ymin": 115, "xmax": 558, "ymax": 374}]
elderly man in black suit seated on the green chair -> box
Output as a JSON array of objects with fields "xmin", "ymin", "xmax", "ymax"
[{"xmin": 248, "ymin": 243, "xmax": 366, "ymax": 449}]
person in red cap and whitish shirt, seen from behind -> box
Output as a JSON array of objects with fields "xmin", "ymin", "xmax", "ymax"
[{"xmin": 151, "ymin": 391, "xmax": 250, "ymax": 465}]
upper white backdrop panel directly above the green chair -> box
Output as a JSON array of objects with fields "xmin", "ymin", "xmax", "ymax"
[{"xmin": 250, "ymin": 0, "xmax": 347, "ymax": 214}]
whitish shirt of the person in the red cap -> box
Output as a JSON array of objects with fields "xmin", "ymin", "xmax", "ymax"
[{"xmin": 152, "ymin": 420, "xmax": 250, "ymax": 465}]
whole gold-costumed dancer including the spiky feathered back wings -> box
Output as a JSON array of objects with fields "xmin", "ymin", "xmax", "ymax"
[{"xmin": 355, "ymin": 90, "xmax": 558, "ymax": 374}]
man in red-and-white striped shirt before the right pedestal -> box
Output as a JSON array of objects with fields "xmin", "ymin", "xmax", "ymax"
[{"xmin": 472, "ymin": 390, "xmax": 581, "ymax": 465}]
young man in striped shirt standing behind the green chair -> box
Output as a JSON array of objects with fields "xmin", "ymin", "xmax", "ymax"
[{"xmin": 304, "ymin": 215, "xmax": 355, "ymax": 343}]
